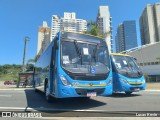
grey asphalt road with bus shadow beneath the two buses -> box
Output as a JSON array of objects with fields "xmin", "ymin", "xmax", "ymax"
[{"xmin": 0, "ymin": 89, "xmax": 160, "ymax": 117}]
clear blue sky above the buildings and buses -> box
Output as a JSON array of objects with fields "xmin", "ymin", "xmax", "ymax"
[{"xmin": 0, "ymin": 0, "xmax": 160, "ymax": 65}]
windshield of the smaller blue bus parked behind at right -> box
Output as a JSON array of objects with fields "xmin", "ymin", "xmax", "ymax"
[{"xmin": 112, "ymin": 55, "xmax": 142, "ymax": 77}]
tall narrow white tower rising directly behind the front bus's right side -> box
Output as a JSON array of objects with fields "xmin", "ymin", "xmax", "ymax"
[{"xmin": 96, "ymin": 6, "xmax": 113, "ymax": 52}]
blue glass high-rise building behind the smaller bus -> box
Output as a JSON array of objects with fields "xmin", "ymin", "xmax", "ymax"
[{"xmin": 115, "ymin": 20, "xmax": 137, "ymax": 52}]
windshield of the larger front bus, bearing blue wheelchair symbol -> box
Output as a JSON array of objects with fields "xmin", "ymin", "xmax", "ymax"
[{"xmin": 61, "ymin": 40, "xmax": 110, "ymax": 74}]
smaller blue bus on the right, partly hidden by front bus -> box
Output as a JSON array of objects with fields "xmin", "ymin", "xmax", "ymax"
[{"xmin": 110, "ymin": 53, "xmax": 146, "ymax": 95}]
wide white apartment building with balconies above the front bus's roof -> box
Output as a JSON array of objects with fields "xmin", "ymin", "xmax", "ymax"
[{"xmin": 52, "ymin": 12, "xmax": 87, "ymax": 39}]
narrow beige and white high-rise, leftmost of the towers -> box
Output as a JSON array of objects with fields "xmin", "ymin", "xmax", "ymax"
[{"xmin": 37, "ymin": 21, "xmax": 51, "ymax": 55}]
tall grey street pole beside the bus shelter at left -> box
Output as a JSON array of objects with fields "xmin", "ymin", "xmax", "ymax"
[{"xmin": 22, "ymin": 36, "xmax": 30, "ymax": 72}]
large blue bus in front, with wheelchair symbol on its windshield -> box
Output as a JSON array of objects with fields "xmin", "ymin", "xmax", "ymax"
[{"xmin": 35, "ymin": 31, "xmax": 112, "ymax": 101}]
